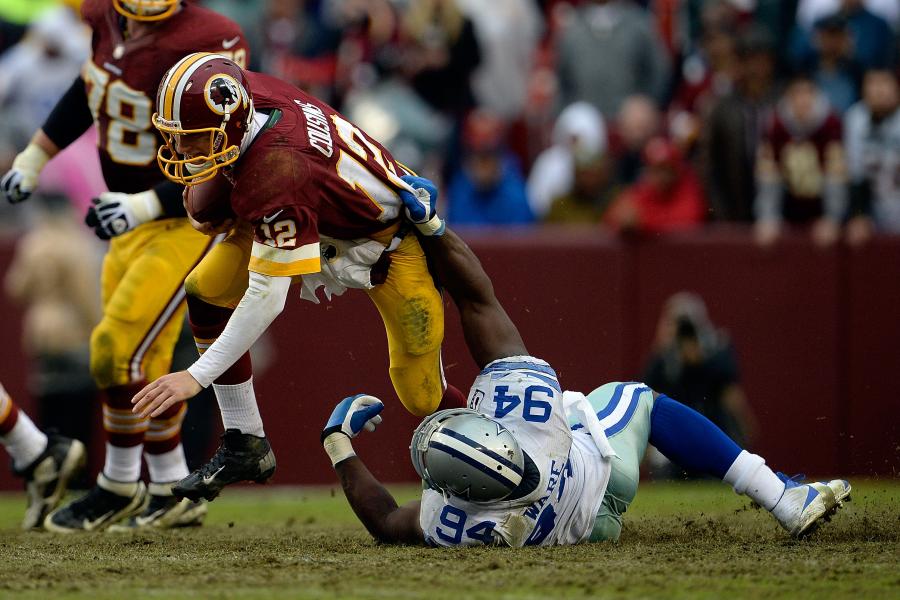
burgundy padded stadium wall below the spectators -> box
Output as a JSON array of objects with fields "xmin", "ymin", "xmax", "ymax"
[{"xmin": 0, "ymin": 228, "xmax": 900, "ymax": 489}]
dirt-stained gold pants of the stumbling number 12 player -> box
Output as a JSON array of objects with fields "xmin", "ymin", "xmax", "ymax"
[{"xmin": 184, "ymin": 223, "xmax": 445, "ymax": 416}]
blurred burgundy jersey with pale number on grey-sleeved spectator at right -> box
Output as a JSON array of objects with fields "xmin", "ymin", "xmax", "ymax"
[{"xmin": 765, "ymin": 111, "xmax": 845, "ymax": 223}]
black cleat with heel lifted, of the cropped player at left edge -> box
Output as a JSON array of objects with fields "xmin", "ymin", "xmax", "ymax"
[{"xmin": 15, "ymin": 434, "xmax": 87, "ymax": 529}]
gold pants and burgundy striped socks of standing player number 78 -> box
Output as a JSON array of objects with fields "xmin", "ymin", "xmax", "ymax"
[{"xmin": 91, "ymin": 219, "xmax": 213, "ymax": 453}]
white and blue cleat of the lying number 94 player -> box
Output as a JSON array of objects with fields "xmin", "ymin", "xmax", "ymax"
[{"xmin": 772, "ymin": 473, "xmax": 850, "ymax": 537}]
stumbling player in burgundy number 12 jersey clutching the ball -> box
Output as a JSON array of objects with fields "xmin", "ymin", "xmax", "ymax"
[{"xmin": 134, "ymin": 53, "xmax": 462, "ymax": 499}]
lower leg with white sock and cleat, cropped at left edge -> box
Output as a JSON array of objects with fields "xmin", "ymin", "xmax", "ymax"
[{"xmin": 0, "ymin": 384, "xmax": 87, "ymax": 529}]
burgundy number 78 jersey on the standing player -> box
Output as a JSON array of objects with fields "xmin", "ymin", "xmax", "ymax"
[{"xmin": 81, "ymin": 0, "xmax": 247, "ymax": 193}]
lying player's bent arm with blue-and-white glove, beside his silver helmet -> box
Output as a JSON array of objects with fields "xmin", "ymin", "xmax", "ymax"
[{"xmin": 322, "ymin": 394, "xmax": 425, "ymax": 544}]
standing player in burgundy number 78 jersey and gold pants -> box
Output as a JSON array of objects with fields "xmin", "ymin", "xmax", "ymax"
[{"xmin": 0, "ymin": 0, "xmax": 247, "ymax": 532}]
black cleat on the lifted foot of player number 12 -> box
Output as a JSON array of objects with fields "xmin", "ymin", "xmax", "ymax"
[{"xmin": 172, "ymin": 429, "xmax": 275, "ymax": 502}]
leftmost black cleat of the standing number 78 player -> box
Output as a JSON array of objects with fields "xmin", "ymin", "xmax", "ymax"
[{"xmin": 44, "ymin": 473, "xmax": 147, "ymax": 533}]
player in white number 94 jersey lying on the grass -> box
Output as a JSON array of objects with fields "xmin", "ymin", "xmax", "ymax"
[{"xmin": 322, "ymin": 180, "xmax": 850, "ymax": 546}]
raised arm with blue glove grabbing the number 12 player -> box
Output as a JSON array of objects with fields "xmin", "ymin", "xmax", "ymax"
[{"xmin": 400, "ymin": 176, "xmax": 528, "ymax": 367}]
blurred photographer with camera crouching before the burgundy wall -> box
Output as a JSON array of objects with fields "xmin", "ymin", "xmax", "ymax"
[{"xmin": 641, "ymin": 292, "xmax": 755, "ymax": 460}]
